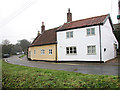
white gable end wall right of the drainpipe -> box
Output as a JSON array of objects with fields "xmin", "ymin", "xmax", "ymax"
[{"xmin": 101, "ymin": 19, "xmax": 118, "ymax": 61}]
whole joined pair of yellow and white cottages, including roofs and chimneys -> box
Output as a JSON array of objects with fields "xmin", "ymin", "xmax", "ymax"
[{"xmin": 28, "ymin": 9, "xmax": 118, "ymax": 62}]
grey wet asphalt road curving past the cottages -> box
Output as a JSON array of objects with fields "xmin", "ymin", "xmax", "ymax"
[{"xmin": 6, "ymin": 56, "xmax": 119, "ymax": 75}]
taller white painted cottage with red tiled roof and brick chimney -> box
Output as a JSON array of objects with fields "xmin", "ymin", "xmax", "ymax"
[{"xmin": 57, "ymin": 9, "xmax": 118, "ymax": 62}]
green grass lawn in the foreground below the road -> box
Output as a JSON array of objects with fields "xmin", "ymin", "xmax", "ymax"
[{"xmin": 2, "ymin": 62, "xmax": 120, "ymax": 88}]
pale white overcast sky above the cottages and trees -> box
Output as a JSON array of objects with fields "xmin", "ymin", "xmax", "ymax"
[{"xmin": 0, "ymin": 0, "xmax": 118, "ymax": 44}]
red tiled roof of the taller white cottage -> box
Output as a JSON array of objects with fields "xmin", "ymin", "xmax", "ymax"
[{"xmin": 58, "ymin": 14, "xmax": 109, "ymax": 31}]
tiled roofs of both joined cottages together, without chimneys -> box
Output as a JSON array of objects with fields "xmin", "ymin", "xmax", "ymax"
[{"xmin": 30, "ymin": 14, "xmax": 108, "ymax": 46}]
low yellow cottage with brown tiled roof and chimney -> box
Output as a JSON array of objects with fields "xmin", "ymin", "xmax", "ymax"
[{"xmin": 28, "ymin": 22, "xmax": 58, "ymax": 61}]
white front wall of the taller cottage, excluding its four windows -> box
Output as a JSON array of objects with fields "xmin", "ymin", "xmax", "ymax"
[{"xmin": 57, "ymin": 26, "xmax": 100, "ymax": 61}]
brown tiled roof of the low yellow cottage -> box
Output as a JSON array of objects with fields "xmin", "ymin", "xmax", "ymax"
[{"xmin": 30, "ymin": 27, "xmax": 59, "ymax": 46}]
